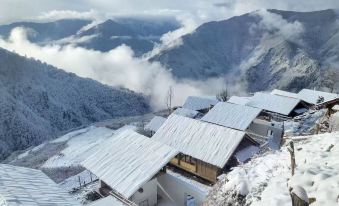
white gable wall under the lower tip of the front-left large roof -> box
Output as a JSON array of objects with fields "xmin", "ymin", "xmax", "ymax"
[{"xmin": 130, "ymin": 178, "xmax": 158, "ymax": 206}]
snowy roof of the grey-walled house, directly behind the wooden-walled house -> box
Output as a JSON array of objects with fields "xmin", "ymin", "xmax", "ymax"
[{"xmin": 201, "ymin": 102, "xmax": 262, "ymax": 131}]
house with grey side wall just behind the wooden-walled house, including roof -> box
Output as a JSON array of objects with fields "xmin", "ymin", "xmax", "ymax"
[{"xmin": 201, "ymin": 102, "xmax": 283, "ymax": 149}]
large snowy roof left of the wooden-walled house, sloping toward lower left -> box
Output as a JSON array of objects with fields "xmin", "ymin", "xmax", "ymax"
[{"xmin": 82, "ymin": 130, "xmax": 178, "ymax": 198}]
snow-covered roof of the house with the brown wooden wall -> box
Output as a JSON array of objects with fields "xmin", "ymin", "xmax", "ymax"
[{"xmin": 152, "ymin": 114, "xmax": 245, "ymax": 168}]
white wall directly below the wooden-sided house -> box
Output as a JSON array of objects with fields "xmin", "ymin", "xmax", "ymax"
[{"xmin": 158, "ymin": 173, "xmax": 208, "ymax": 206}]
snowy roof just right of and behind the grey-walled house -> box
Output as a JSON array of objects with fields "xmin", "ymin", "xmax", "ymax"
[{"xmin": 246, "ymin": 92, "xmax": 300, "ymax": 115}]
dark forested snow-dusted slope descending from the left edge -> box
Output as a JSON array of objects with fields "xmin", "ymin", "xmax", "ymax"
[{"xmin": 0, "ymin": 49, "xmax": 150, "ymax": 159}]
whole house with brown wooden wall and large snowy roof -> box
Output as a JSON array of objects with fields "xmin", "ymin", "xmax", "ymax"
[{"xmin": 152, "ymin": 114, "xmax": 259, "ymax": 183}]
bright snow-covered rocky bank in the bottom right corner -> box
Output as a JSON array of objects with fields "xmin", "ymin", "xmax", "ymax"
[{"xmin": 207, "ymin": 133, "xmax": 339, "ymax": 206}]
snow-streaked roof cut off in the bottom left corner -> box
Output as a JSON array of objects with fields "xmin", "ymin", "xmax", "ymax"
[{"xmin": 0, "ymin": 164, "xmax": 80, "ymax": 206}]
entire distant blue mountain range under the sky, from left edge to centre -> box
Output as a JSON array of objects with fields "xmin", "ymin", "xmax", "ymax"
[{"xmin": 0, "ymin": 17, "xmax": 180, "ymax": 56}]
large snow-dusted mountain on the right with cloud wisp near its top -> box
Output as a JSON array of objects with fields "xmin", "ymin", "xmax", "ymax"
[{"xmin": 151, "ymin": 10, "xmax": 339, "ymax": 92}]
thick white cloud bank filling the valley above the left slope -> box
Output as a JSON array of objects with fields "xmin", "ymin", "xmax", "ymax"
[{"xmin": 0, "ymin": 28, "xmax": 225, "ymax": 109}]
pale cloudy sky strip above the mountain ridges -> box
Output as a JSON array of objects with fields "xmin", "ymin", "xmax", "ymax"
[{"xmin": 0, "ymin": 0, "xmax": 339, "ymax": 24}]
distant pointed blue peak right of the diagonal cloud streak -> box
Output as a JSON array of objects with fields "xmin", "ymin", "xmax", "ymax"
[{"xmin": 77, "ymin": 18, "xmax": 179, "ymax": 56}]
